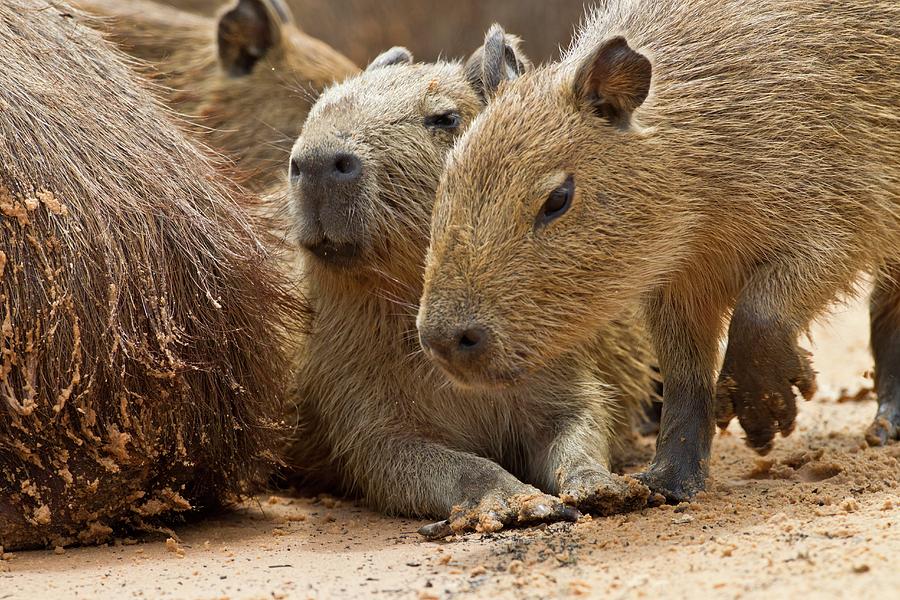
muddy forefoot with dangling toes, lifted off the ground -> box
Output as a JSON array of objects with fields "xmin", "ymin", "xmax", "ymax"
[{"xmin": 716, "ymin": 343, "xmax": 816, "ymax": 454}]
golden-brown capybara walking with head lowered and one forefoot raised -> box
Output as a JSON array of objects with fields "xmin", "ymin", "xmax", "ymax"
[{"xmin": 419, "ymin": 0, "xmax": 900, "ymax": 500}]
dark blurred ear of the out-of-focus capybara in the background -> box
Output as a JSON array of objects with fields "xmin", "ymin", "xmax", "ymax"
[{"xmin": 216, "ymin": 0, "xmax": 293, "ymax": 77}]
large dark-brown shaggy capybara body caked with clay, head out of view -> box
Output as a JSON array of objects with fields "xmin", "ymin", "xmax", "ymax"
[{"xmin": 0, "ymin": 0, "xmax": 299, "ymax": 550}]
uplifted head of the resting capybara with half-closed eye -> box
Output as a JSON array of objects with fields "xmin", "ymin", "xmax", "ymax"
[{"xmin": 290, "ymin": 26, "xmax": 528, "ymax": 296}]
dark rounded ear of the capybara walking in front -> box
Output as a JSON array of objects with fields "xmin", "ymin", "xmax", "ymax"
[{"xmin": 574, "ymin": 37, "xmax": 653, "ymax": 127}]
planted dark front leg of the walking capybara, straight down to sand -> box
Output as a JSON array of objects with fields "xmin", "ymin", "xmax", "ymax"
[{"xmin": 636, "ymin": 292, "xmax": 724, "ymax": 502}]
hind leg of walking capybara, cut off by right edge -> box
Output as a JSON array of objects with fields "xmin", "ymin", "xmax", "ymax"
[{"xmin": 866, "ymin": 266, "xmax": 900, "ymax": 446}]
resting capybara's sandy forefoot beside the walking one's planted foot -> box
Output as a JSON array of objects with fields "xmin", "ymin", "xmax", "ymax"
[{"xmin": 559, "ymin": 468, "xmax": 650, "ymax": 516}]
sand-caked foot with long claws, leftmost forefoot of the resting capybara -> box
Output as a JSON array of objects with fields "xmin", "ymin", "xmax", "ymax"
[{"xmin": 419, "ymin": 488, "xmax": 581, "ymax": 539}]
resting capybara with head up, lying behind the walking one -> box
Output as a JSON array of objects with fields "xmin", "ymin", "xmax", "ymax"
[{"xmin": 290, "ymin": 27, "xmax": 651, "ymax": 536}]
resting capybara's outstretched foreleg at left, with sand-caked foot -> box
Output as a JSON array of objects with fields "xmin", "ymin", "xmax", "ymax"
[{"xmin": 366, "ymin": 440, "xmax": 579, "ymax": 538}]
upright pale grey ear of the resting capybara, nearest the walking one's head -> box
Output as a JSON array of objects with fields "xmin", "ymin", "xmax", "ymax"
[{"xmin": 465, "ymin": 23, "xmax": 531, "ymax": 100}]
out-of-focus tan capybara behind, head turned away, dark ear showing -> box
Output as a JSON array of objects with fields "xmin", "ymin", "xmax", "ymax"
[{"xmin": 75, "ymin": 0, "xmax": 359, "ymax": 191}]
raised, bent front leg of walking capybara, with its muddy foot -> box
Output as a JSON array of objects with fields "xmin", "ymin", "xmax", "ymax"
[{"xmin": 716, "ymin": 304, "xmax": 816, "ymax": 454}]
